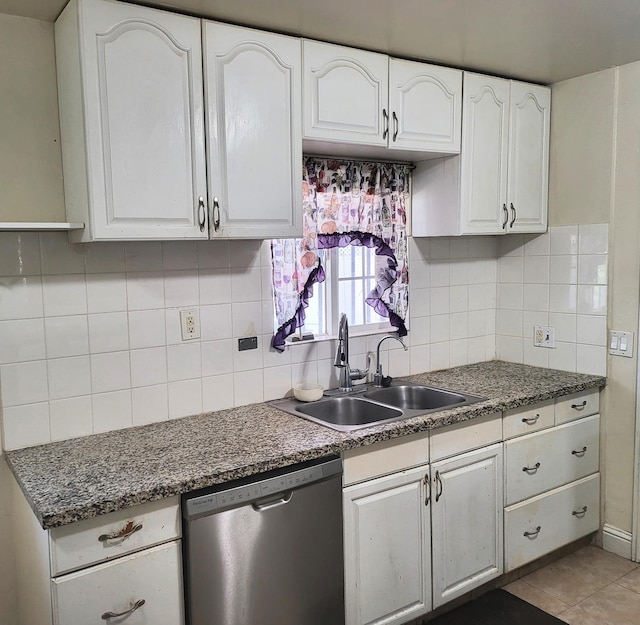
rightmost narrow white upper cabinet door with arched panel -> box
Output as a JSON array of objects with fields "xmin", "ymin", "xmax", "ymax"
[{"xmin": 507, "ymin": 81, "xmax": 551, "ymax": 232}]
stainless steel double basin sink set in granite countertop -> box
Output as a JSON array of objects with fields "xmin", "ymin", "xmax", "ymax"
[{"xmin": 270, "ymin": 381, "xmax": 484, "ymax": 432}]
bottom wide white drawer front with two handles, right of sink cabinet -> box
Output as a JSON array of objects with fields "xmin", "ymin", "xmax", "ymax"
[{"xmin": 504, "ymin": 473, "xmax": 600, "ymax": 573}]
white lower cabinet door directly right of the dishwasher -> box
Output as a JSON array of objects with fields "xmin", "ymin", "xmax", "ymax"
[{"xmin": 344, "ymin": 466, "xmax": 431, "ymax": 625}]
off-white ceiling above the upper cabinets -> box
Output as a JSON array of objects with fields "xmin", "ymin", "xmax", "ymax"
[{"xmin": 0, "ymin": 0, "xmax": 640, "ymax": 83}]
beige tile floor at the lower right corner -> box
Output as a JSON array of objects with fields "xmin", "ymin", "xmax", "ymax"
[{"xmin": 504, "ymin": 545, "xmax": 640, "ymax": 625}]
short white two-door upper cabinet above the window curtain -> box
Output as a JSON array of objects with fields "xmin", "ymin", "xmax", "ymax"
[{"xmin": 303, "ymin": 40, "xmax": 462, "ymax": 158}]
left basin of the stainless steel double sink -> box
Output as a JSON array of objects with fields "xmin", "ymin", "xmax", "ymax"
[{"xmin": 297, "ymin": 396, "xmax": 404, "ymax": 429}]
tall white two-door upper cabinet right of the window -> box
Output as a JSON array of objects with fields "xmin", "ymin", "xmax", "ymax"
[{"xmin": 412, "ymin": 73, "xmax": 551, "ymax": 236}]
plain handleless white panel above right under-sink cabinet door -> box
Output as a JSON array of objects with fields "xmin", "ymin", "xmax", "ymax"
[{"xmin": 429, "ymin": 412, "xmax": 502, "ymax": 462}]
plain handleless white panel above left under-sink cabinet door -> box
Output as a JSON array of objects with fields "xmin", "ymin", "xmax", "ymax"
[{"xmin": 342, "ymin": 432, "xmax": 429, "ymax": 486}]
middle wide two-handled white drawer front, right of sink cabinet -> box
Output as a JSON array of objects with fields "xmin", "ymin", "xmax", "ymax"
[{"xmin": 505, "ymin": 415, "xmax": 600, "ymax": 505}]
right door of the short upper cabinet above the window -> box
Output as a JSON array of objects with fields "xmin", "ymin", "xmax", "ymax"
[{"xmin": 389, "ymin": 59, "xmax": 462, "ymax": 154}]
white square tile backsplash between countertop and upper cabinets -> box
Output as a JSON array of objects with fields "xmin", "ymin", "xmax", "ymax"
[{"xmin": 0, "ymin": 225, "xmax": 607, "ymax": 449}]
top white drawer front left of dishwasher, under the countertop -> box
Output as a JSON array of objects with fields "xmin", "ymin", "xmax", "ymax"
[{"xmin": 50, "ymin": 497, "xmax": 180, "ymax": 576}]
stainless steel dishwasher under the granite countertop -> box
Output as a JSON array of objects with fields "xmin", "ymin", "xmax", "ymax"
[{"xmin": 182, "ymin": 458, "xmax": 344, "ymax": 625}]
